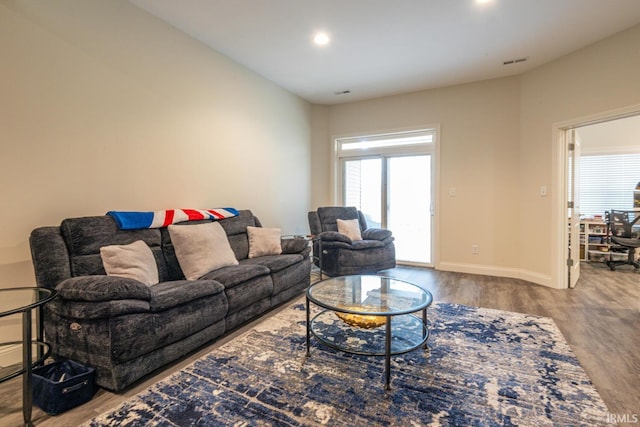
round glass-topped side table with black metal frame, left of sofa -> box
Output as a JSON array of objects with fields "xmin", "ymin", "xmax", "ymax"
[{"xmin": 0, "ymin": 287, "xmax": 56, "ymax": 426}]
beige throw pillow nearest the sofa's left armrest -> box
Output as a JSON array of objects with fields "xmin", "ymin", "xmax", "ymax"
[{"xmin": 100, "ymin": 240, "xmax": 158, "ymax": 285}]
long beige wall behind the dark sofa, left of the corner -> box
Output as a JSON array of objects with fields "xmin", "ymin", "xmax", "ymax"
[{"xmin": 0, "ymin": 0, "xmax": 311, "ymax": 287}]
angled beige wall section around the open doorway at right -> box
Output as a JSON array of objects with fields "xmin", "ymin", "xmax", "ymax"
[{"xmin": 519, "ymin": 25, "xmax": 640, "ymax": 286}]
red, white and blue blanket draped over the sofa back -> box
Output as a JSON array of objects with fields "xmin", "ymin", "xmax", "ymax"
[{"xmin": 107, "ymin": 208, "xmax": 238, "ymax": 230}]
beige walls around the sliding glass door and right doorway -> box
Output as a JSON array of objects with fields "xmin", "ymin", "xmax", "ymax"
[{"xmin": 320, "ymin": 26, "xmax": 640, "ymax": 287}]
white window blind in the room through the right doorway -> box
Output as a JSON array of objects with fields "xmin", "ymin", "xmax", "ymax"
[{"xmin": 580, "ymin": 153, "xmax": 640, "ymax": 216}]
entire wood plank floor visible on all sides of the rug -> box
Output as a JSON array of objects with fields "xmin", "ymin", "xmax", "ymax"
[{"xmin": 0, "ymin": 263, "xmax": 640, "ymax": 427}]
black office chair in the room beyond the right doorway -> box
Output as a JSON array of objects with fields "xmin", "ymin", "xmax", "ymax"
[{"xmin": 606, "ymin": 210, "xmax": 640, "ymax": 271}]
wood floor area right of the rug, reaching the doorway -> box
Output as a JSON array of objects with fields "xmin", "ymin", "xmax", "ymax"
[{"xmin": 393, "ymin": 263, "xmax": 640, "ymax": 425}]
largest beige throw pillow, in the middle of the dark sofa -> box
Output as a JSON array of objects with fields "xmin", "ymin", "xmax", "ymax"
[{"xmin": 168, "ymin": 222, "xmax": 238, "ymax": 280}]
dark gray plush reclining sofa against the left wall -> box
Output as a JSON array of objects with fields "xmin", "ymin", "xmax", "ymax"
[{"xmin": 30, "ymin": 210, "xmax": 311, "ymax": 391}]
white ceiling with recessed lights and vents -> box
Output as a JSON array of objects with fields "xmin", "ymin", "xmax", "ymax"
[{"xmin": 129, "ymin": 0, "xmax": 640, "ymax": 104}]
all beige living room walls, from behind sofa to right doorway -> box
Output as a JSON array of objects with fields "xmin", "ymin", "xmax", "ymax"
[{"xmin": 0, "ymin": 0, "xmax": 640, "ymax": 298}]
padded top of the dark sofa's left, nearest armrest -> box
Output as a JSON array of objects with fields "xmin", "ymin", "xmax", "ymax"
[{"xmin": 56, "ymin": 276, "xmax": 151, "ymax": 302}]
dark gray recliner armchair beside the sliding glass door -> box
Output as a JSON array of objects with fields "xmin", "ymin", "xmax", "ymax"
[{"xmin": 309, "ymin": 206, "xmax": 396, "ymax": 276}]
